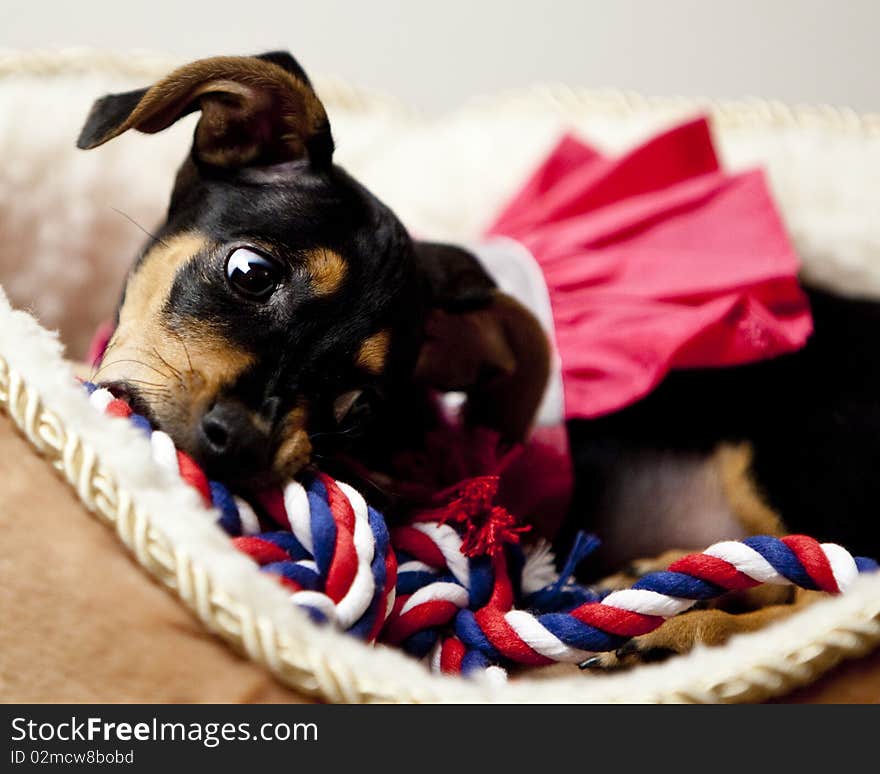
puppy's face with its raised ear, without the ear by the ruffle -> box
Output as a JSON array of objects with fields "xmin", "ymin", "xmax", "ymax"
[{"xmin": 78, "ymin": 54, "xmax": 421, "ymax": 482}]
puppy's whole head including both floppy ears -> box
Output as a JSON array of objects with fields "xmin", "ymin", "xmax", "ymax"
[{"xmin": 78, "ymin": 53, "xmax": 549, "ymax": 494}]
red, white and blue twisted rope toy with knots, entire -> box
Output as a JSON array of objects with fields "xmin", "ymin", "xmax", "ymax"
[{"xmin": 85, "ymin": 382, "xmax": 878, "ymax": 675}]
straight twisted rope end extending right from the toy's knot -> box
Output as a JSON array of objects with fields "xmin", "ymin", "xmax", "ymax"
[{"xmin": 440, "ymin": 535, "xmax": 877, "ymax": 671}]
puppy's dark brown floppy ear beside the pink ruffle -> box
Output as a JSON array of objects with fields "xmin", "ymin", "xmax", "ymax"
[{"xmin": 415, "ymin": 243, "xmax": 550, "ymax": 443}]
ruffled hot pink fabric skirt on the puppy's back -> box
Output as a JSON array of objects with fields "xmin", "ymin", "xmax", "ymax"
[{"xmin": 489, "ymin": 118, "xmax": 812, "ymax": 418}]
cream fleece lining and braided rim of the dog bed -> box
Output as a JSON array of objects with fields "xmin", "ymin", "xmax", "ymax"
[{"xmin": 0, "ymin": 51, "xmax": 880, "ymax": 702}]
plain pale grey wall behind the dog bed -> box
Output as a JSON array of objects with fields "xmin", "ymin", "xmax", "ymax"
[{"xmin": 0, "ymin": 0, "xmax": 880, "ymax": 111}]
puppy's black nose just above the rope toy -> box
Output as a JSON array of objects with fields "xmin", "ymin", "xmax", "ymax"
[{"xmin": 196, "ymin": 400, "xmax": 268, "ymax": 478}]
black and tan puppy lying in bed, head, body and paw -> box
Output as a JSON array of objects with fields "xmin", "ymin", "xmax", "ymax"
[{"xmin": 79, "ymin": 53, "xmax": 880, "ymax": 668}]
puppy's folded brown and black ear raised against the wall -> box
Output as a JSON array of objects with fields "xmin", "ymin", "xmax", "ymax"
[{"xmin": 77, "ymin": 52, "xmax": 333, "ymax": 167}]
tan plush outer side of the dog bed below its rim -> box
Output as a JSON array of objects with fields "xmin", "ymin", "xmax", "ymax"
[{"xmin": 0, "ymin": 413, "xmax": 306, "ymax": 703}]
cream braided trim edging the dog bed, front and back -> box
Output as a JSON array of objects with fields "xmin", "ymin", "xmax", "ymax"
[{"xmin": 0, "ymin": 50, "xmax": 880, "ymax": 702}]
